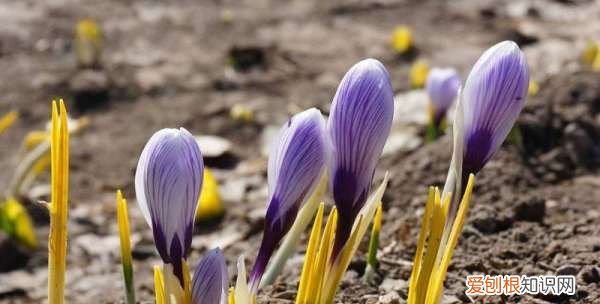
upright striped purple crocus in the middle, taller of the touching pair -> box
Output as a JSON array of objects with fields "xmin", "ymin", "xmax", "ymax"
[{"xmin": 327, "ymin": 59, "xmax": 394, "ymax": 257}]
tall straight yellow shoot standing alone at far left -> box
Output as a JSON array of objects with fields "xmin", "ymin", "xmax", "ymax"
[{"xmin": 48, "ymin": 100, "xmax": 69, "ymax": 304}]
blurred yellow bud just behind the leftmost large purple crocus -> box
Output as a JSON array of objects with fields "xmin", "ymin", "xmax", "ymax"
[{"xmin": 196, "ymin": 167, "xmax": 225, "ymax": 223}]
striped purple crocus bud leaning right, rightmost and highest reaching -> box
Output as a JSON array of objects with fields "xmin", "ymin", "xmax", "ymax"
[{"xmin": 461, "ymin": 41, "xmax": 529, "ymax": 177}]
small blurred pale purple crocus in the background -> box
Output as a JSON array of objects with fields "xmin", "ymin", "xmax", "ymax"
[{"xmin": 425, "ymin": 68, "xmax": 460, "ymax": 128}]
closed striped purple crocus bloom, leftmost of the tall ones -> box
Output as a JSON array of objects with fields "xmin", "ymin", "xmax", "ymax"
[{"xmin": 135, "ymin": 128, "xmax": 203, "ymax": 281}]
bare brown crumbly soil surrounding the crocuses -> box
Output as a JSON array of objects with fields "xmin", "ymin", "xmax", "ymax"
[{"xmin": 0, "ymin": 0, "xmax": 600, "ymax": 303}]
